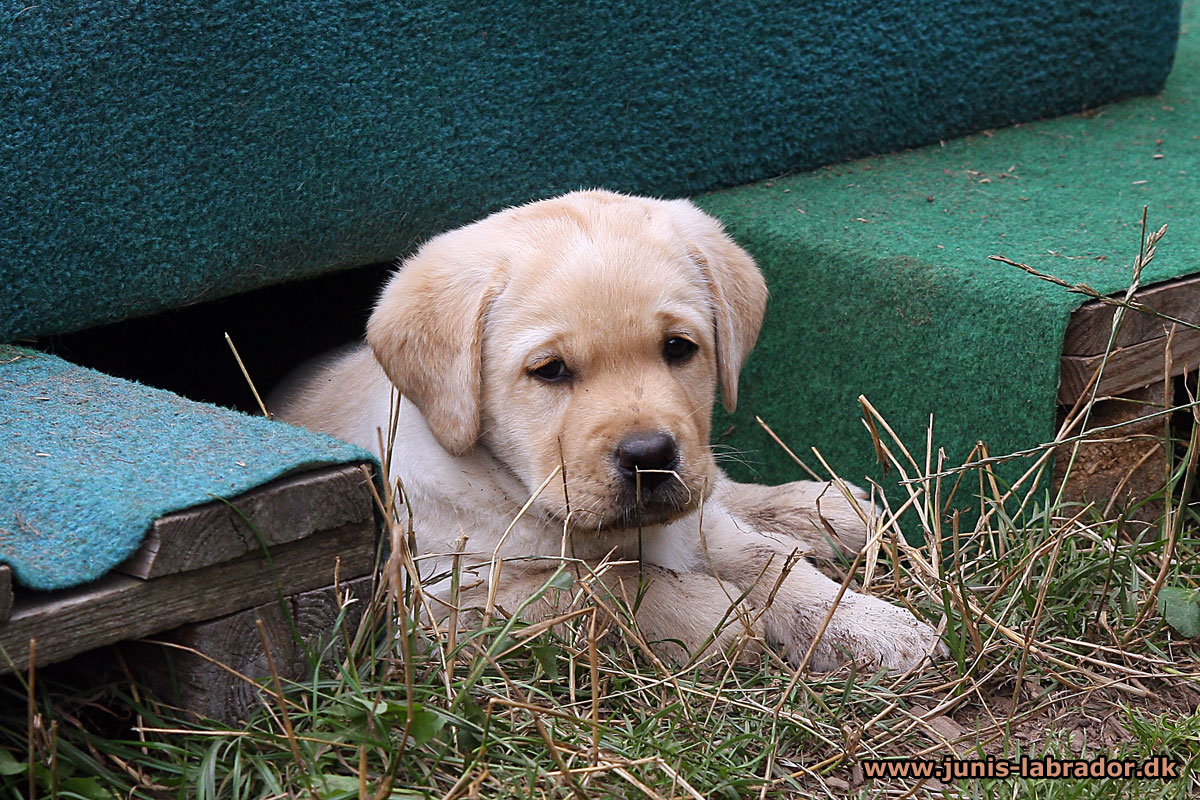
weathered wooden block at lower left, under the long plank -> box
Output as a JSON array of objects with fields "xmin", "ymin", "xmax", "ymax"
[{"xmin": 130, "ymin": 576, "xmax": 374, "ymax": 724}]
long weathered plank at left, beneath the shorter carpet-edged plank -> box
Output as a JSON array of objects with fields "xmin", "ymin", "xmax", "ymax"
[{"xmin": 0, "ymin": 521, "xmax": 376, "ymax": 673}]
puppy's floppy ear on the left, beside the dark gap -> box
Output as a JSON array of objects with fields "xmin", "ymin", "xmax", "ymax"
[{"xmin": 367, "ymin": 231, "xmax": 506, "ymax": 456}]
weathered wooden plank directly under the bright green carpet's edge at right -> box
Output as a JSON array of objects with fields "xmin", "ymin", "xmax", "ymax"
[{"xmin": 1058, "ymin": 329, "xmax": 1200, "ymax": 405}]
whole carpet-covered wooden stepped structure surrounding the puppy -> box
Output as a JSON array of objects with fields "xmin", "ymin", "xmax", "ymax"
[{"xmin": 0, "ymin": 0, "xmax": 1200, "ymax": 714}]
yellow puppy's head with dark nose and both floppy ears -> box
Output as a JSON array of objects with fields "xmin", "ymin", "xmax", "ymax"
[{"xmin": 367, "ymin": 192, "xmax": 767, "ymax": 529}]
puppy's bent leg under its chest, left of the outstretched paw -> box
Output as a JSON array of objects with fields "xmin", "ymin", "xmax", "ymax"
[{"xmin": 458, "ymin": 564, "xmax": 762, "ymax": 664}]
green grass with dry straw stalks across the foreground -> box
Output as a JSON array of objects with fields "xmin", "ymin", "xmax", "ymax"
[{"xmin": 0, "ymin": 225, "xmax": 1200, "ymax": 800}]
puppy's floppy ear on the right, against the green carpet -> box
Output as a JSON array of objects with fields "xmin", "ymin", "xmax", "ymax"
[{"xmin": 670, "ymin": 200, "xmax": 767, "ymax": 411}]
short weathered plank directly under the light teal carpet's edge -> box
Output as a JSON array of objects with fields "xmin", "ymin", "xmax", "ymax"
[{"xmin": 118, "ymin": 464, "xmax": 373, "ymax": 578}]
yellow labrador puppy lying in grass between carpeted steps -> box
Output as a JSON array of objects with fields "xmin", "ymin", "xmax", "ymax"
[{"xmin": 276, "ymin": 191, "xmax": 942, "ymax": 670}]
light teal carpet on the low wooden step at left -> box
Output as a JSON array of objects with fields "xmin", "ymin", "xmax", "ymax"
[{"xmin": 0, "ymin": 344, "xmax": 373, "ymax": 589}]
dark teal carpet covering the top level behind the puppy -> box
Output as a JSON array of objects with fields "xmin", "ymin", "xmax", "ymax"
[{"xmin": 0, "ymin": 0, "xmax": 1178, "ymax": 341}]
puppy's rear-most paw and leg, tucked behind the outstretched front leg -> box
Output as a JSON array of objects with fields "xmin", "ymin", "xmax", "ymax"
[{"xmin": 713, "ymin": 475, "xmax": 874, "ymax": 561}]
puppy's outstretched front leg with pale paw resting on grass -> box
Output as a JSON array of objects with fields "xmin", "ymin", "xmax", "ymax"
[{"xmin": 703, "ymin": 503, "xmax": 946, "ymax": 672}]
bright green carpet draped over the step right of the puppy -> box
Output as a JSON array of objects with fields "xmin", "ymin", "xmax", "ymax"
[{"xmin": 697, "ymin": 1, "xmax": 1200, "ymax": 506}]
